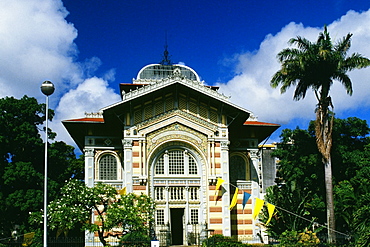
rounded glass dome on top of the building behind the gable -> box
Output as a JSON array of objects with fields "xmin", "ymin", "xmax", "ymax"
[{"xmin": 136, "ymin": 64, "xmax": 200, "ymax": 81}]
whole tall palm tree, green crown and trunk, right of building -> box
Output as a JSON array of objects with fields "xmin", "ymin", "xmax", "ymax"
[{"xmin": 271, "ymin": 26, "xmax": 370, "ymax": 243}]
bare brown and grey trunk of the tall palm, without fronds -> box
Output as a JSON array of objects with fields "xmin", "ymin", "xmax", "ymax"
[{"xmin": 315, "ymin": 98, "xmax": 336, "ymax": 244}]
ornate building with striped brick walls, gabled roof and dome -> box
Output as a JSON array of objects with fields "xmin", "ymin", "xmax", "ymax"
[{"xmin": 63, "ymin": 59, "xmax": 279, "ymax": 245}]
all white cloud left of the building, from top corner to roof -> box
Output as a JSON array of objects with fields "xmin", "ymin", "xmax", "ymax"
[{"xmin": 0, "ymin": 0, "xmax": 119, "ymax": 149}]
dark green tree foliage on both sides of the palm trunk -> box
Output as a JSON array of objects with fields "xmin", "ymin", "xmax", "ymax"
[{"xmin": 266, "ymin": 118, "xmax": 370, "ymax": 246}]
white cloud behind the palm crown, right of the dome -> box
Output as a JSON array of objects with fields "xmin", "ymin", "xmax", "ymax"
[{"xmin": 218, "ymin": 10, "xmax": 370, "ymax": 127}]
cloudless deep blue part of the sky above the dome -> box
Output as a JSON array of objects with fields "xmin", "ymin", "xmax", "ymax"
[{"xmin": 63, "ymin": 0, "xmax": 370, "ymax": 84}]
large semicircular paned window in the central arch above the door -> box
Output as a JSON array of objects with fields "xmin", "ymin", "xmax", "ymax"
[{"xmin": 154, "ymin": 149, "xmax": 198, "ymax": 175}]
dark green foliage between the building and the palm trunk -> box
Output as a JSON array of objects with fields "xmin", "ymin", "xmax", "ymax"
[{"xmin": 265, "ymin": 128, "xmax": 325, "ymax": 238}]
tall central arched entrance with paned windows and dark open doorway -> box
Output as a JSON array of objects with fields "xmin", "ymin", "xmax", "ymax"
[{"xmin": 150, "ymin": 142, "xmax": 206, "ymax": 245}]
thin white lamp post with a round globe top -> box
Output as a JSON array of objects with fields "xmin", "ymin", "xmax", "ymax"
[{"xmin": 41, "ymin": 81, "xmax": 55, "ymax": 247}]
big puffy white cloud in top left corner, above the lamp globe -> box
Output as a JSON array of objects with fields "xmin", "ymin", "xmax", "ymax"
[{"xmin": 0, "ymin": 0, "xmax": 80, "ymax": 97}]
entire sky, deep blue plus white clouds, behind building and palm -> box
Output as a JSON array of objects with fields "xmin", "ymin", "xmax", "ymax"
[{"xmin": 0, "ymin": 0, "xmax": 370, "ymax": 149}]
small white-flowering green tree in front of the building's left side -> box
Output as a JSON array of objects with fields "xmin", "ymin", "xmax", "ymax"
[{"xmin": 48, "ymin": 179, "xmax": 155, "ymax": 246}]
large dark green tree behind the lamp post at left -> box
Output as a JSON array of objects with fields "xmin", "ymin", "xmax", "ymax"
[{"xmin": 0, "ymin": 96, "xmax": 83, "ymax": 238}]
